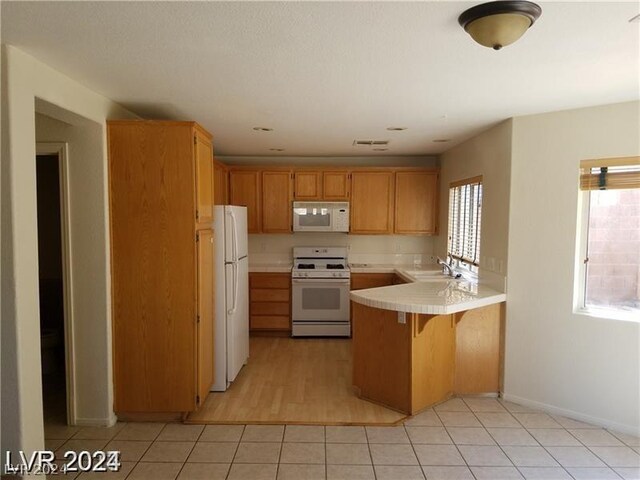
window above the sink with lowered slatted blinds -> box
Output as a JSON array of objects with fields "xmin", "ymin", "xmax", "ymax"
[{"xmin": 447, "ymin": 177, "xmax": 482, "ymax": 271}]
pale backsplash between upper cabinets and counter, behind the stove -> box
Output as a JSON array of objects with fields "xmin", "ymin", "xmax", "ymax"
[{"xmin": 249, "ymin": 233, "xmax": 435, "ymax": 264}]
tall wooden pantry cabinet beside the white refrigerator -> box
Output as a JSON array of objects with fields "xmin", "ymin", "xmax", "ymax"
[{"xmin": 108, "ymin": 120, "xmax": 214, "ymax": 417}]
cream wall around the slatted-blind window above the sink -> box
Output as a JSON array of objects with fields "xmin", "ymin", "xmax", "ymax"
[{"xmin": 435, "ymin": 120, "xmax": 512, "ymax": 288}]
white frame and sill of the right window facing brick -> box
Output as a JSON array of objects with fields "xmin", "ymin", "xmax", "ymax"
[{"xmin": 573, "ymin": 157, "xmax": 640, "ymax": 323}]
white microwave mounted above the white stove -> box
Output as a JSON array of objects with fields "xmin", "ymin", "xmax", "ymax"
[{"xmin": 293, "ymin": 202, "xmax": 349, "ymax": 233}]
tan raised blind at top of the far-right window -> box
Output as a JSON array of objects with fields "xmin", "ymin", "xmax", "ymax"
[{"xmin": 580, "ymin": 157, "xmax": 640, "ymax": 190}]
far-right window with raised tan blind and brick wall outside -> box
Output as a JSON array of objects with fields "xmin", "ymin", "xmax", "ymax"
[{"xmin": 578, "ymin": 157, "xmax": 640, "ymax": 317}]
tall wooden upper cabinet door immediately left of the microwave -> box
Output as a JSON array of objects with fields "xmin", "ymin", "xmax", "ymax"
[{"xmin": 262, "ymin": 171, "xmax": 292, "ymax": 233}]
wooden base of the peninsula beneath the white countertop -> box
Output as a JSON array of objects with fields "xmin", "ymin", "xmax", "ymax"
[{"xmin": 351, "ymin": 302, "xmax": 502, "ymax": 415}]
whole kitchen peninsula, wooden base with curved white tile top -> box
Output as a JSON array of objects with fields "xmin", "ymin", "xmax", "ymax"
[{"xmin": 351, "ymin": 271, "xmax": 506, "ymax": 414}]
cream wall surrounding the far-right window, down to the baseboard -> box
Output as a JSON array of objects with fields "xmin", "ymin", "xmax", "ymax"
[{"xmin": 505, "ymin": 102, "xmax": 640, "ymax": 435}]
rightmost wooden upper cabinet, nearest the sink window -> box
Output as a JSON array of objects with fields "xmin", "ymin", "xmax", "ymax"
[{"xmin": 394, "ymin": 170, "xmax": 438, "ymax": 235}]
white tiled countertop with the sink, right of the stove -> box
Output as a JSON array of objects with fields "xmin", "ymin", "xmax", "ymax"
[{"xmin": 350, "ymin": 265, "xmax": 507, "ymax": 315}]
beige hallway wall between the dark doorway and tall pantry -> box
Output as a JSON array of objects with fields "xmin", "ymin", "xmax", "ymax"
[{"xmin": 36, "ymin": 110, "xmax": 112, "ymax": 425}]
